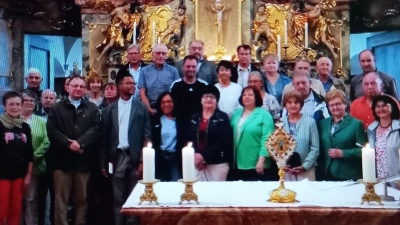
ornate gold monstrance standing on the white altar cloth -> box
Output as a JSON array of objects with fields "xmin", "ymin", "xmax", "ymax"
[{"xmin": 265, "ymin": 120, "xmax": 296, "ymax": 203}]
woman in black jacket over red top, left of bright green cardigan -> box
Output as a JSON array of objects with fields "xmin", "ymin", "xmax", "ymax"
[{"xmin": 185, "ymin": 86, "xmax": 233, "ymax": 181}]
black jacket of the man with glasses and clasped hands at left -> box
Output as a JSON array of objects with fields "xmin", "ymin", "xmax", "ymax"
[{"xmin": 46, "ymin": 98, "xmax": 100, "ymax": 172}]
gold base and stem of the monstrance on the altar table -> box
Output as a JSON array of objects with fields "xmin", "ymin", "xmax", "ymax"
[{"xmin": 269, "ymin": 168, "xmax": 296, "ymax": 203}]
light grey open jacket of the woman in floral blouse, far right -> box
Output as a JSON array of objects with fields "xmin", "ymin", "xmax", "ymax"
[{"xmin": 367, "ymin": 120, "xmax": 400, "ymax": 187}]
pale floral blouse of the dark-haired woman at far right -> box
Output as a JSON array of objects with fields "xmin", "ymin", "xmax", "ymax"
[{"xmin": 375, "ymin": 130, "xmax": 390, "ymax": 178}]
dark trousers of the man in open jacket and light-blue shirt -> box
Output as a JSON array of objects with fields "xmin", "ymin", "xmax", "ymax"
[{"xmin": 112, "ymin": 150, "xmax": 139, "ymax": 225}]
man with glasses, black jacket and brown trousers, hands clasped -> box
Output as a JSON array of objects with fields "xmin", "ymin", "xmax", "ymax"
[{"xmin": 46, "ymin": 75, "xmax": 100, "ymax": 225}]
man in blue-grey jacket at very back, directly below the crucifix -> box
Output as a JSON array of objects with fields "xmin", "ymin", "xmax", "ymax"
[{"xmin": 175, "ymin": 40, "xmax": 218, "ymax": 85}]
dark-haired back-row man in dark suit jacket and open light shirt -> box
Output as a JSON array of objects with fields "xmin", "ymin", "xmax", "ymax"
[{"xmin": 231, "ymin": 45, "xmax": 265, "ymax": 88}]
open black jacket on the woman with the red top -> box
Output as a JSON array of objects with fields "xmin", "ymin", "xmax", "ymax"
[{"xmin": 185, "ymin": 109, "xmax": 233, "ymax": 164}]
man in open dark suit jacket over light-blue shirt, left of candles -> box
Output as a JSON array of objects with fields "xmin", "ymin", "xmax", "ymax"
[{"xmin": 100, "ymin": 73, "xmax": 151, "ymax": 225}]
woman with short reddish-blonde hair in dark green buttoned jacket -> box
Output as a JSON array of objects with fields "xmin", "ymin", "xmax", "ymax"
[{"xmin": 317, "ymin": 90, "xmax": 367, "ymax": 181}]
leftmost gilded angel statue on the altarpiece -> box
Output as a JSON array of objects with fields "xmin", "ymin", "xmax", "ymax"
[{"xmin": 96, "ymin": 4, "xmax": 140, "ymax": 61}]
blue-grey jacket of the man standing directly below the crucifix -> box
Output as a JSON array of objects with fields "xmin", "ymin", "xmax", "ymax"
[{"xmin": 175, "ymin": 59, "xmax": 218, "ymax": 85}]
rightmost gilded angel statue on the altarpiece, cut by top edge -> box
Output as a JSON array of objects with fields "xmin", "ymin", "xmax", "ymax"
[{"xmin": 292, "ymin": 0, "xmax": 340, "ymax": 59}]
